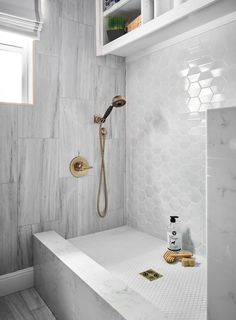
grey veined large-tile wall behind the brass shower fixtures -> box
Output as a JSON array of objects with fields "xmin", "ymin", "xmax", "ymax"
[{"xmin": 0, "ymin": 0, "xmax": 125, "ymax": 274}]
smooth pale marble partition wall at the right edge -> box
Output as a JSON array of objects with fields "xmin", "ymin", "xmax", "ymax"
[{"xmin": 207, "ymin": 107, "xmax": 236, "ymax": 320}]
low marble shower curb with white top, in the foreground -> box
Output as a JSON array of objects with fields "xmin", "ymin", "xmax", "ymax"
[{"xmin": 34, "ymin": 232, "xmax": 166, "ymax": 320}]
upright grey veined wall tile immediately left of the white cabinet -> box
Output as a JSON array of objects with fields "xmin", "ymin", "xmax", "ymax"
[{"xmin": 60, "ymin": 19, "xmax": 96, "ymax": 100}]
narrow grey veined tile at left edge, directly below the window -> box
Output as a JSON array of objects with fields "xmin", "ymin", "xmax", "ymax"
[{"xmin": 0, "ymin": 105, "xmax": 17, "ymax": 183}]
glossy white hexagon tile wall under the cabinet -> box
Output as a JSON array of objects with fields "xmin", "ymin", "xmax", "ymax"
[{"xmin": 126, "ymin": 22, "xmax": 236, "ymax": 253}]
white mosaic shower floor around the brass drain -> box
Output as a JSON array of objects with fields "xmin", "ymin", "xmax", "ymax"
[{"xmin": 70, "ymin": 226, "xmax": 207, "ymax": 320}]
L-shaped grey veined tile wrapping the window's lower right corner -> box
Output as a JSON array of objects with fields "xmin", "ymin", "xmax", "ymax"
[{"xmin": 18, "ymin": 54, "xmax": 59, "ymax": 138}]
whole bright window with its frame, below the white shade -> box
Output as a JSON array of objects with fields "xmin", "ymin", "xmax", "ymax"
[{"xmin": 0, "ymin": 31, "xmax": 33, "ymax": 104}]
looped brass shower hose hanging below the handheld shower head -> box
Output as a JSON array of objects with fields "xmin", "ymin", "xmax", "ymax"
[{"xmin": 97, "ymin": 124, "xmax": 108, "ymax": 218}]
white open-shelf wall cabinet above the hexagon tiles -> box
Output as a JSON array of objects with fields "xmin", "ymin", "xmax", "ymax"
[{"xmin": 96, "ymin": 0, "xmax": 236, "ymax": 57}]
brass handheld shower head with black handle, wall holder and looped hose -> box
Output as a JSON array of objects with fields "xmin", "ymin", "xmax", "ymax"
[{"xmin": 94, "ymin": 96, "xmax": 126, "ymax": 218}]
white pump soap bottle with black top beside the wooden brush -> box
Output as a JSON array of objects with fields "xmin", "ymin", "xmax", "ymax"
[{"xmin": 167, "ymin": 216, "xmax": 182, "ymax": 251}]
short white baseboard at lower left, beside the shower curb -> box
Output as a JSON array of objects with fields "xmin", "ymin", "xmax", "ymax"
[{"xmin": 0, "ymin": 267, "xmax": 34, "ymax": 297}]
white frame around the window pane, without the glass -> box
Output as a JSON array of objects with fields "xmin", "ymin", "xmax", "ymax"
[{"xmin": 0, "ymin": 31, "xmax": 33, "ymax": 105}]
